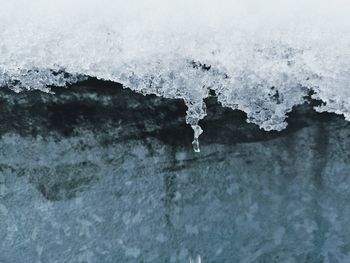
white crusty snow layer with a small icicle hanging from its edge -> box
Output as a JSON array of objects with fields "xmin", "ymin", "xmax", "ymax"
[{"xmin": 0, "ymin": 0, "xmax": 350, "ymax": 150}]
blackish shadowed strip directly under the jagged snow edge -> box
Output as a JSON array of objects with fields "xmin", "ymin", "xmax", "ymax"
[{"xmin": 0, "ymin": 78, "xmax": 343, "ymax": 151}]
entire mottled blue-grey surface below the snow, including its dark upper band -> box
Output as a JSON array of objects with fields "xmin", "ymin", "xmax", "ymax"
[{"xmin": 0, "ymin": 85, "xmax": 350, "ymax": 263}]
